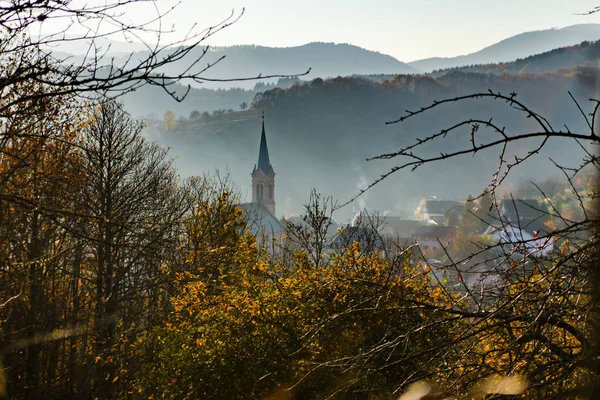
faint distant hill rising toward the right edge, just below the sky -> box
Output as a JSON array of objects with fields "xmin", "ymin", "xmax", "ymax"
[{"xmin": 408, "ymin": 24, "xmax": 600, "ymax": 73}]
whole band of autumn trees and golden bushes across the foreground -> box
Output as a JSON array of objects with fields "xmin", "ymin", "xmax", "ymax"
[{"xmin": 0, "ymin": 92, "xmax": 598, "ymax": 399}]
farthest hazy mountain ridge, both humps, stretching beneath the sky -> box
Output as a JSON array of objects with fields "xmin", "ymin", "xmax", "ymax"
[{"xmin": 52, "ymin": 24, "xmax": 600, "ymax": 90}]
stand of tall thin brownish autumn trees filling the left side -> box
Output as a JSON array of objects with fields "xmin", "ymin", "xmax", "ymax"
[{"xmin": 0, "ymin": 94, "xmax": 184, "ymax": 398}]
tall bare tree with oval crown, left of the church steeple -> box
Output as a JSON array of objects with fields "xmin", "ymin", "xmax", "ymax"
[{"xmin": 75, "ymin": 102, "xmax": 187, "ymax": 397}]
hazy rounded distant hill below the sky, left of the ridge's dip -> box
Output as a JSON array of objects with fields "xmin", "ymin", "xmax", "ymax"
[{"xmin": 59, "ymin": 42, "xmax": 417, "ymax": 90}]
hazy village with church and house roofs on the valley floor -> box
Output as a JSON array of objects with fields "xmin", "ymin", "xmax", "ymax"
[{"xmin": 239, "ymin": 115, "xmax": 557, "ymax": 278}]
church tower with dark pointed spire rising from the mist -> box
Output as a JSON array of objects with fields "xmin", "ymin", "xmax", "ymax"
[{"xmin": 251, "ymin": 113, "xmax": 275, "ymax": 215}]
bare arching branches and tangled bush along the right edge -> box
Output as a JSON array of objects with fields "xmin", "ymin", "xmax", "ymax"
[{"xmin": 330, "ymin": 91, "xmax": 600, "ymax": 399}]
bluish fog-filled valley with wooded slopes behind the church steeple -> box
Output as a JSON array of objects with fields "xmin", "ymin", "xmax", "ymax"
[{"xmin": 125, "ymin": 27, "xmax": 600, "ymax": 222}]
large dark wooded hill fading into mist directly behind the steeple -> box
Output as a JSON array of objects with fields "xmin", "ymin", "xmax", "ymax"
[{"xmin": 148, "ymin": 67, "xmax": 598, "ymax": 221}]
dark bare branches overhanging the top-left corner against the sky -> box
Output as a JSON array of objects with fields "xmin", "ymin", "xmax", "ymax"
[{"xmin": 0, "ymin": 0, "xmax": 310, "ymax": 109}]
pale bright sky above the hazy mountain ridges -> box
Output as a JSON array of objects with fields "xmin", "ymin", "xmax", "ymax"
[{"xmin": 75, "ymin": 0, "xmax": 600, "ymax": 61}]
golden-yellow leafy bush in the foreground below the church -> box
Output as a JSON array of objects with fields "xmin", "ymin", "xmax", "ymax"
[{"xmin": 146, "ymin": 225, "xmax": 460, "ymax": 398}]
